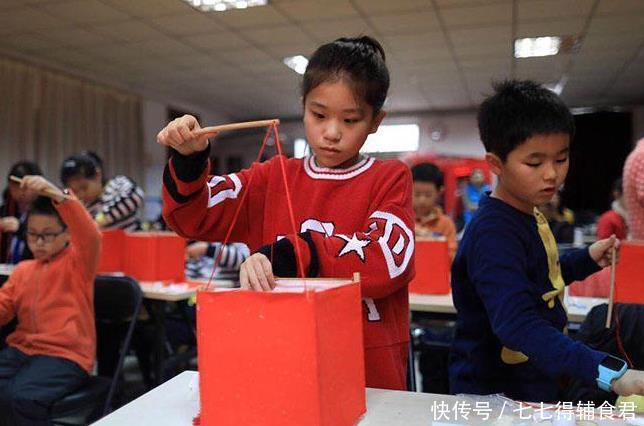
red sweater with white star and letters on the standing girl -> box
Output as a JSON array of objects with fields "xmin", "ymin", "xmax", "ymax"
[{"xmin": 163, "ymin": 150, "xmax": 414, "ymax": 348}]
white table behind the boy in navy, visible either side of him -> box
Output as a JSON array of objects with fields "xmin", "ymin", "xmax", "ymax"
[{"xmin": 409, "ymin": 293, "xmax": 608, "ymax": 323}]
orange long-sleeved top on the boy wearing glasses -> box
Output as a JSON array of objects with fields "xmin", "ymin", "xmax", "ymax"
[{"xmin": 0, "ymin": 199, "xmax": 101, "ymax": 372}]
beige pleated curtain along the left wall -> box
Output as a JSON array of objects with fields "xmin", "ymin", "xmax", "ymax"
[{"xmin": 0, "ymin": 57, "xmax": 144, "ymax": 189}]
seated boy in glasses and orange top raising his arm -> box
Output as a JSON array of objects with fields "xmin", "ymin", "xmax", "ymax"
[{"xmin": 0, "ymin": 176, "xmax": 101, "ymax": 425}]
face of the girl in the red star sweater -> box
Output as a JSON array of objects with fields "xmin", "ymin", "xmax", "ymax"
[{"xmin": 304, "ymin": 79, "xmax": 385, "ymax": 168}]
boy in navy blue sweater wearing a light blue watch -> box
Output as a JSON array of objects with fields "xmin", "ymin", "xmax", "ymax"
[{"xmin": 450, "ymin": 81, "xmax": 644, "ymax": 402}]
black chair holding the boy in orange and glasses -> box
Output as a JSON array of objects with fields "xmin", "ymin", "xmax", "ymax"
[{"xmin": 50, "ymin": 276, "xmax": 143, "ymax": 425}]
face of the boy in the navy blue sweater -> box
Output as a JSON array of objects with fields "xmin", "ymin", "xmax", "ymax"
[{"xmin": 486, "ymin": 133, "xmax": 570, "ymax": 214}]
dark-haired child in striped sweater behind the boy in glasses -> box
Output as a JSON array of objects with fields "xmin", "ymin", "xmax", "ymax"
[{"xmin": 60, "ymin": 151, "xmax": 144, "ymax": 231}]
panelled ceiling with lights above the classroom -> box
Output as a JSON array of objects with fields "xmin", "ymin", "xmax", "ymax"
[{"xmin": 0, "ymin": 0, "xmax": 644, "ymax": 119}]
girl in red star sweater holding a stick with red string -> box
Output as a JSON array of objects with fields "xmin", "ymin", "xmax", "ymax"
[{"xmin": 158, "ymin": 36, "xmax": 414, "ymax": 389}]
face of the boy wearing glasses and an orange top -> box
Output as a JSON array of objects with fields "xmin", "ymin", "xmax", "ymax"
[{"xmin": 27, "ymin": 214, "xmax": 69, "ymax": 260}]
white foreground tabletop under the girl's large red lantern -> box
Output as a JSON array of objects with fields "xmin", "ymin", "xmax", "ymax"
[{"xmin": 94, "ymin": 371, "xmax": 644, "ymax": 426}]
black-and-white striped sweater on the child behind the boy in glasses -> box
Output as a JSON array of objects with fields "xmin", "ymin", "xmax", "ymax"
[{"xmin": 87, "ymin": 176, "xmax": 144, "ymax": 231}]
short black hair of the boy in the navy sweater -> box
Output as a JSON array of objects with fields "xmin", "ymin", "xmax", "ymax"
[{"xmin": 477, "ymin": 80, "xmax": 575, "ymax": 161}]
